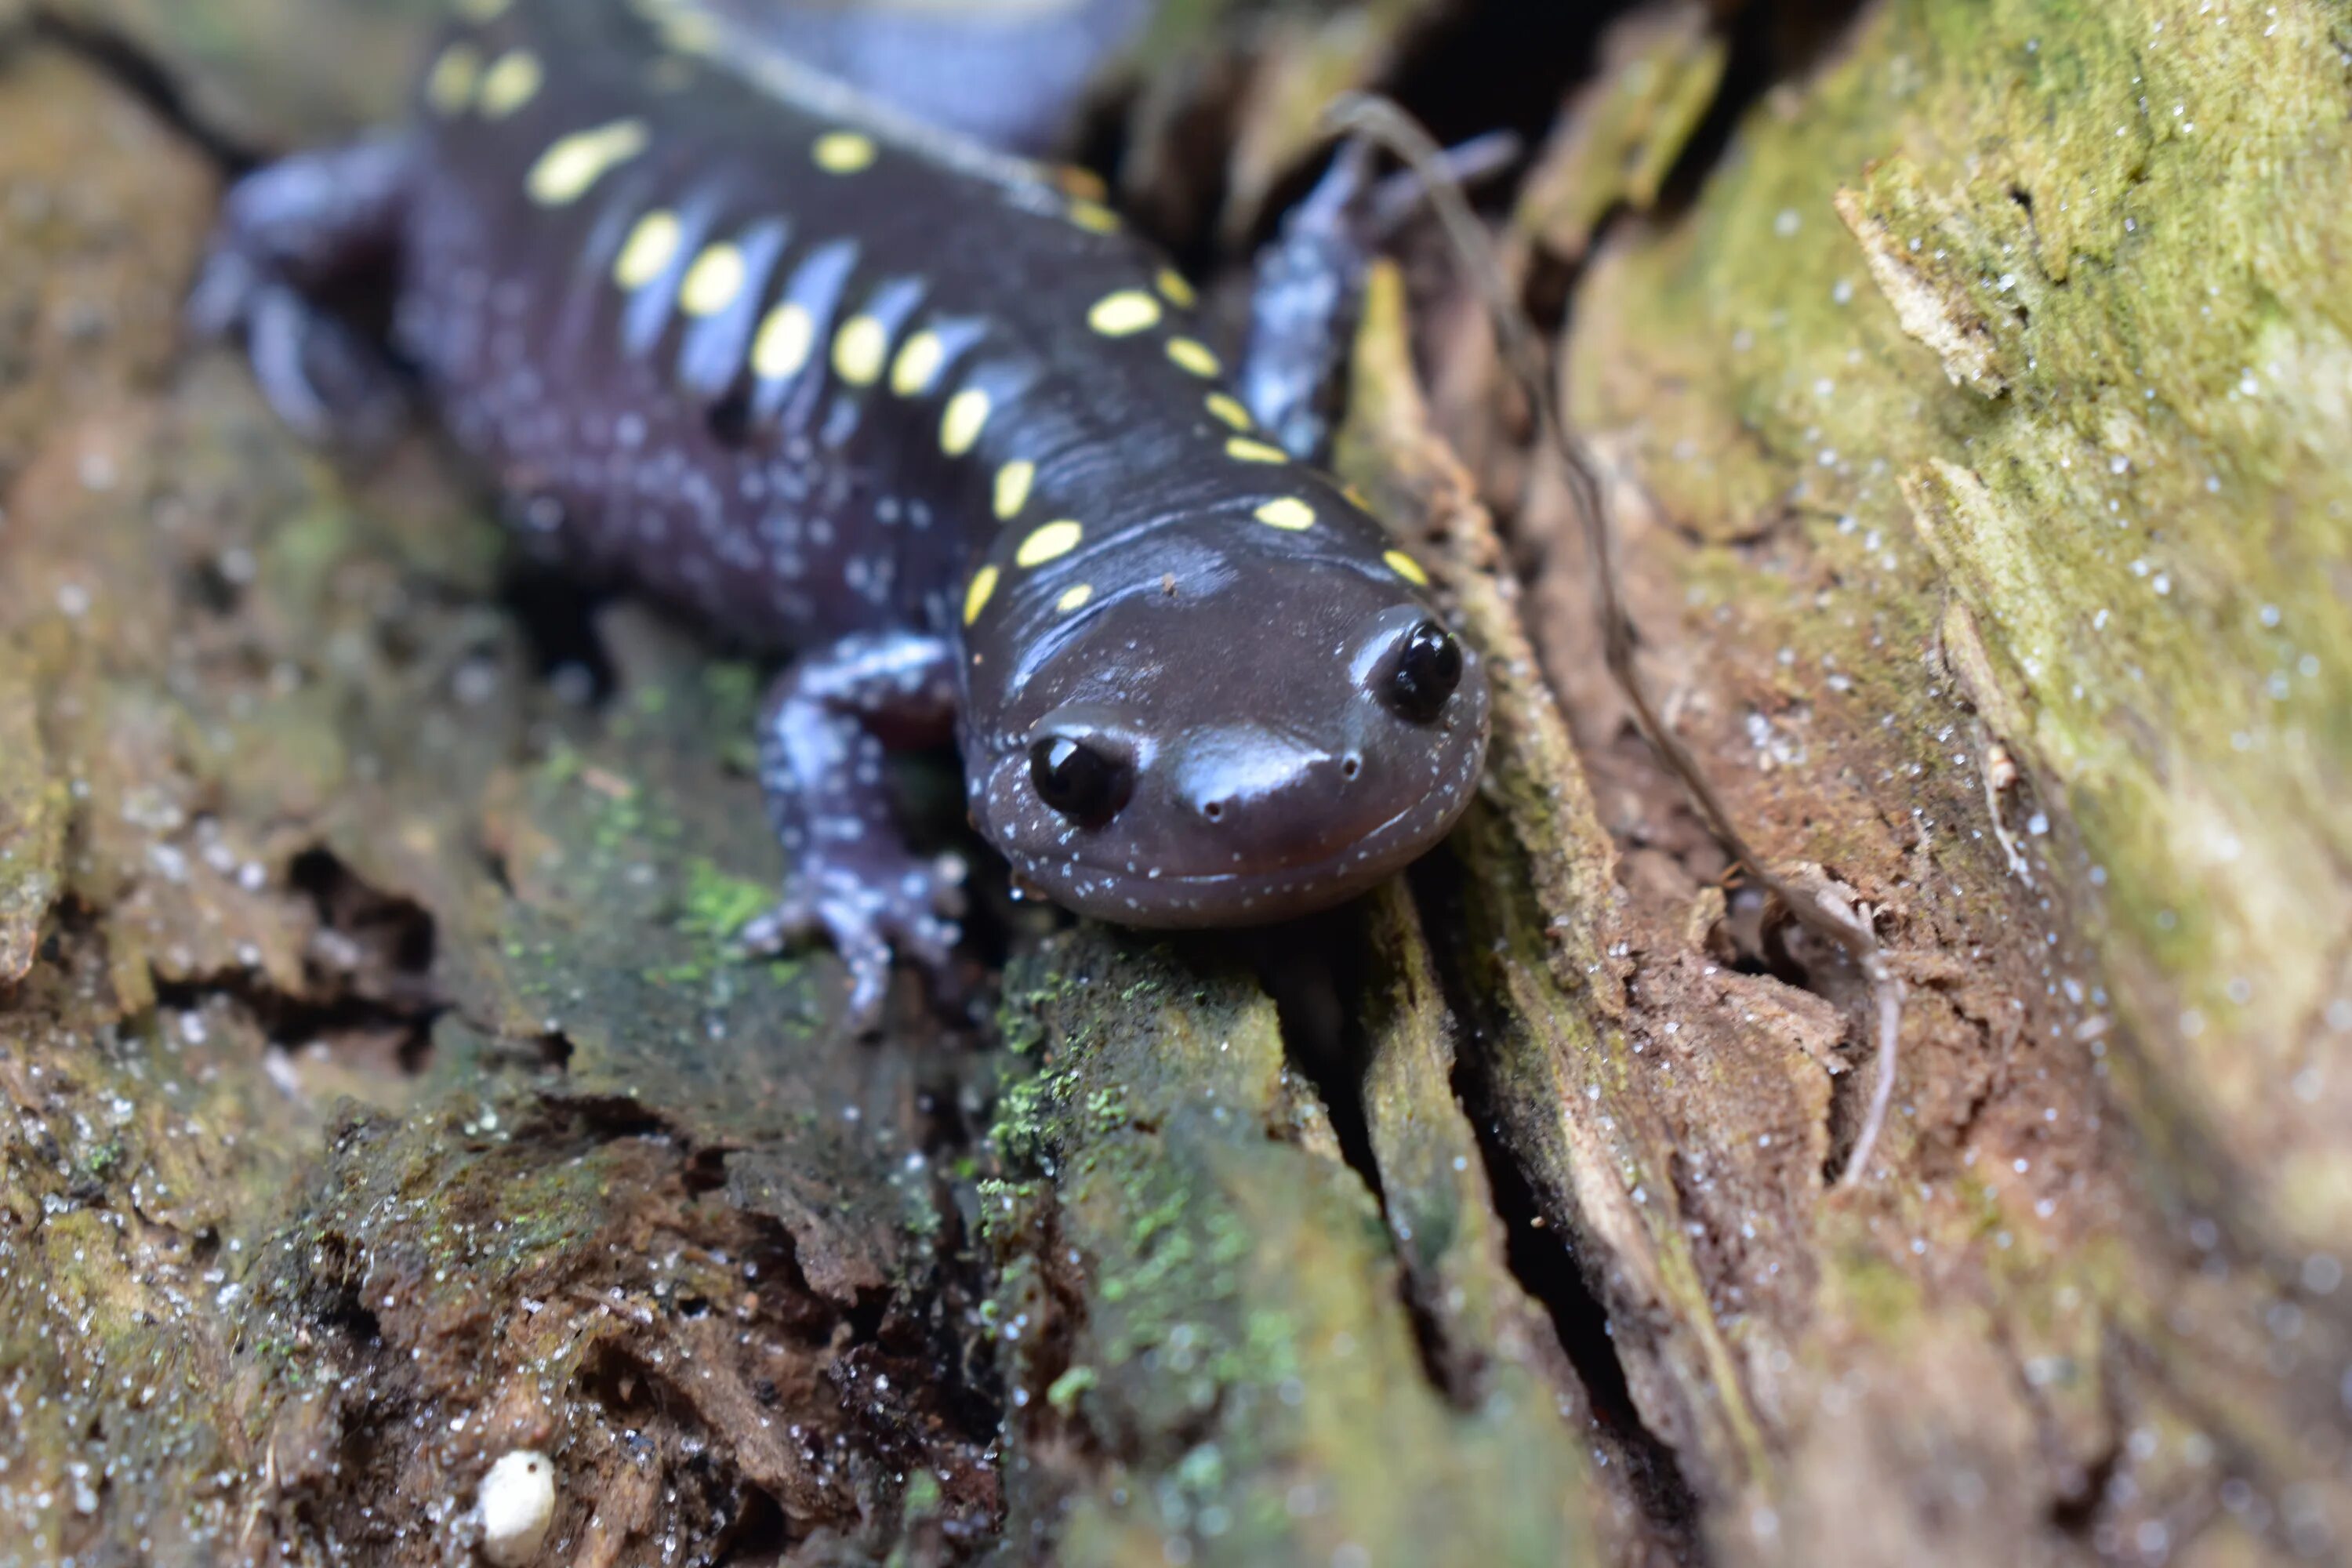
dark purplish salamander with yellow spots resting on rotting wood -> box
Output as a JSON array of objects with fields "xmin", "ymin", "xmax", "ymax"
[{"xmin": 191, "ymin": 0, "xmax": 1486, "ymax": 1018}]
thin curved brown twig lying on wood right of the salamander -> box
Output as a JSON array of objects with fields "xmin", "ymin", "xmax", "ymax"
[{"xmin": 1324, "ymin": 94, "xmax": 1903, "ymax": 1187}]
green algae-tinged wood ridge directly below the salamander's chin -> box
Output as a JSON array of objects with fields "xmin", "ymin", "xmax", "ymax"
[{"xmin": 990, "ymin": 928, "xmax": 1592, "ymax": 1563}]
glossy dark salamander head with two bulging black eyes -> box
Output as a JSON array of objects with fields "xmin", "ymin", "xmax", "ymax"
[{"xmin": 967, "ymin": 560, "xmax": 1486, "ymax": 926}]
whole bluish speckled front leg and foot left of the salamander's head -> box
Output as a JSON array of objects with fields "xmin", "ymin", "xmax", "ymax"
[{"xmin": 743, "ymin": 633, "xmax": 964, "ymax": 1029}]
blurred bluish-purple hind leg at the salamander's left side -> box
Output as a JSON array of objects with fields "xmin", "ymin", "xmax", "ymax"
[{"xmin": 188, "ymin": 139, "xmax": 414, "ymax": 442}]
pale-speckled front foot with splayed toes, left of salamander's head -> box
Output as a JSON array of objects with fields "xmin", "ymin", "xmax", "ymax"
[{"xmin": 741, "ymin": 855, "xmax": 964, "ymax": 1034}]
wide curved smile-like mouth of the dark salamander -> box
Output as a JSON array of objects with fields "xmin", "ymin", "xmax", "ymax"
[{"xmin": 1007, "ymin": 727, "xmax": 1486, "ymax": 931}]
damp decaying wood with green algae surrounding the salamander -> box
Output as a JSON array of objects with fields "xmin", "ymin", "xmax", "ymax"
[{"xmin": 0, "ymin": 0, "xmax": 2352, "ymax": 1568}]
